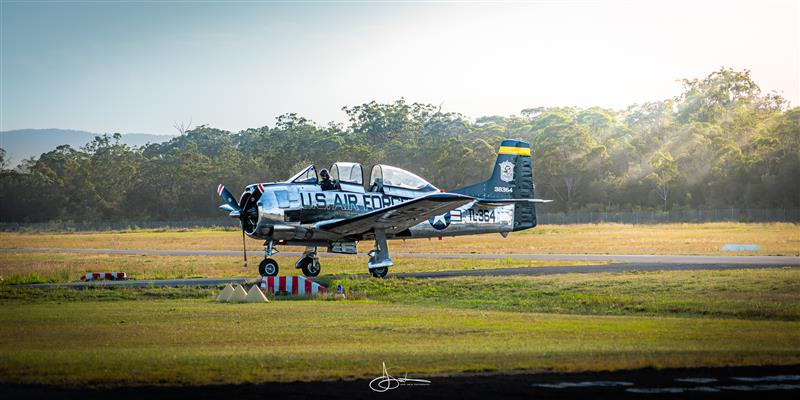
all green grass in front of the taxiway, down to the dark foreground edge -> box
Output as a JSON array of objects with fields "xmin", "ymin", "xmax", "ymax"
[{"xmin": 0, "ymin": 268, "xmax": 800, "ymax": 385}]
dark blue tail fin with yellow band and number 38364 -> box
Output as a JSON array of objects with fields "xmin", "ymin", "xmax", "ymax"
[{"xmin": 452, "ymin": 139, "xmax": 536, "ymax": 231}]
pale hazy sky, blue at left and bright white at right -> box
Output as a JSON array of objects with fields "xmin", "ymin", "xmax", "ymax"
[{"xmin": 0, "ymin": 0, "xmax": 800, "ymax": 133}]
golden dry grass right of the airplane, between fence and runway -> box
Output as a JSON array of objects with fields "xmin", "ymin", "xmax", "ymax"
[{"xmin": 392, "ymin": 223, "xmax": 800, "ymax": 255}]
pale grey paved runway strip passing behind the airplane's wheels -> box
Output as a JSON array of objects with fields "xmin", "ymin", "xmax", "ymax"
[{"xmin": 0, "ymin": 247, "xmax": 800, "ymax": 266}]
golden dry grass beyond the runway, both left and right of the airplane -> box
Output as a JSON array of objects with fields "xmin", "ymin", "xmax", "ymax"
[{"xmin": 0, "ymin": 223, "xmax": 800, "ymax": 255}]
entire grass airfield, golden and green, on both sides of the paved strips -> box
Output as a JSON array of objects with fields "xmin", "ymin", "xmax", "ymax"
[{"xmin": 0, "ymin": 224, "xmax": 800, "ymax": 386}]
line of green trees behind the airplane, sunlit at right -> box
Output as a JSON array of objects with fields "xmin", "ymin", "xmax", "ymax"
[{"xmin": 0, "ymin": 68, "xmax": 800, "ymax": 222}]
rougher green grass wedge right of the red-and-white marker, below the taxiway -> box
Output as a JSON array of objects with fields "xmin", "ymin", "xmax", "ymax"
[{"xmin": 340, "ymin": 268, "xmax": 800, "ymax": 321}]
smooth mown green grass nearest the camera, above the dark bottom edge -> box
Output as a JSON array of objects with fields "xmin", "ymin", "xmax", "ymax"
[{"xmin": 0, "ymin": 300, "xmax": 800, "ymax": 384}]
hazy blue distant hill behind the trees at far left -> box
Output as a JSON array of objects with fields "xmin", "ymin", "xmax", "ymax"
[{"xmin": 0, "ymin": 129, "xmax": 175, "ymax": 168}]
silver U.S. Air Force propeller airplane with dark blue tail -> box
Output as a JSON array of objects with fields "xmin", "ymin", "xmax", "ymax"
[{"xmin": 217, "ymin": 140, "xmax": 550, "ymax": 278}]
